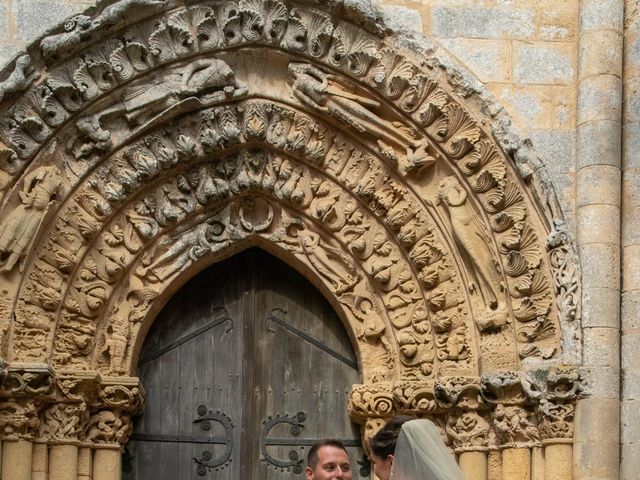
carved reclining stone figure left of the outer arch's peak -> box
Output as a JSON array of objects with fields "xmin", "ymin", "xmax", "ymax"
[{"xmin": 75, "ymin": 58, "xmax": 247, "ymax": 158}]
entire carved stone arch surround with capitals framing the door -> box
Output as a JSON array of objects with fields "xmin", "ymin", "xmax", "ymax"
[{"xmin": 0, "ymin": 0, "xmax": 580, "ymax": 451}]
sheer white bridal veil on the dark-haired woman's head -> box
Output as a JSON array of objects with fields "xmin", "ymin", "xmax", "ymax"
[{"xmin": 391, "ymin": 420, "xmax": 463, "ymax": 480}]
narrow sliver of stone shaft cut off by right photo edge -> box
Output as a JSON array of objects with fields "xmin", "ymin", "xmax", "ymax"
[{"xmin": 620, "ymin": 2, "xmax": 640, "ymax": 480}]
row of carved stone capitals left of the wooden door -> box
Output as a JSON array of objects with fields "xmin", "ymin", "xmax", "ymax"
[{"xmin": 0, "ymin": 364, "xmax": 143, "ymax": 445}]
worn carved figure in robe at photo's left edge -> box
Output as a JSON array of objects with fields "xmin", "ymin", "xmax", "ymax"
[{"xmin": 0, "ymin": 166, "xmax": 62, "ymax": 271}]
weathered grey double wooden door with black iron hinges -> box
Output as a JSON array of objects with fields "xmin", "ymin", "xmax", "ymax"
[{"xmin": 123, "ymin": 249, "xmax": 369, "ymax": 480}]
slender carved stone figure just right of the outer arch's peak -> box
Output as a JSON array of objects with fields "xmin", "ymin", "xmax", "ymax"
[{"xmin": 289, "ymin": 63, "xmax": 435, "ymax": 171}]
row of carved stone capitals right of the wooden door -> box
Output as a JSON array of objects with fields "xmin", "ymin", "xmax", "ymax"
[{"xmin": 349, "ymin": 367, "xmax": 582, "ymax": 452}]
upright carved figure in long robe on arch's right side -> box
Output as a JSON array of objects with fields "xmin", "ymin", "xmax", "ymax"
[{"xmin": 437, "ymin": 176, "xmax": 503, "ymax": 310}]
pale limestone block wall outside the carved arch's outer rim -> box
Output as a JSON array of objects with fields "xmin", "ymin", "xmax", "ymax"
[{"xmin": 0, "ymin": 0, "xmax": 578, "ymax": 229}]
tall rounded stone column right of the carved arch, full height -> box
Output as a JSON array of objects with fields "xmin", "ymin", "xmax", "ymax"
[{"xmin": 574, "ymin": 0, "xmax": 624, "ymax": 480}]
